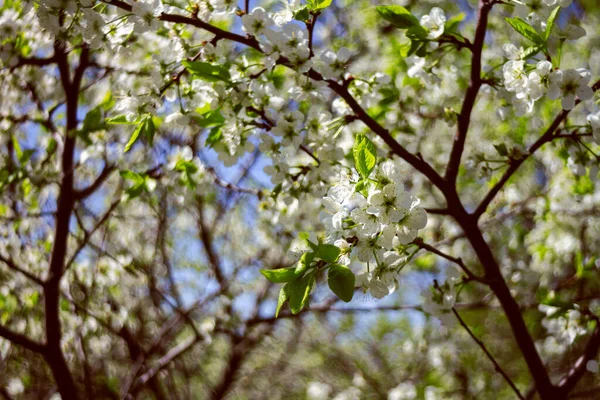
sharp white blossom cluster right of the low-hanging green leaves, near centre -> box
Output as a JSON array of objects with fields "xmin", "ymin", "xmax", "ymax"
[{"xmin": 320, "ymin": 160, "xmax": 427, "ymax": 299}]
